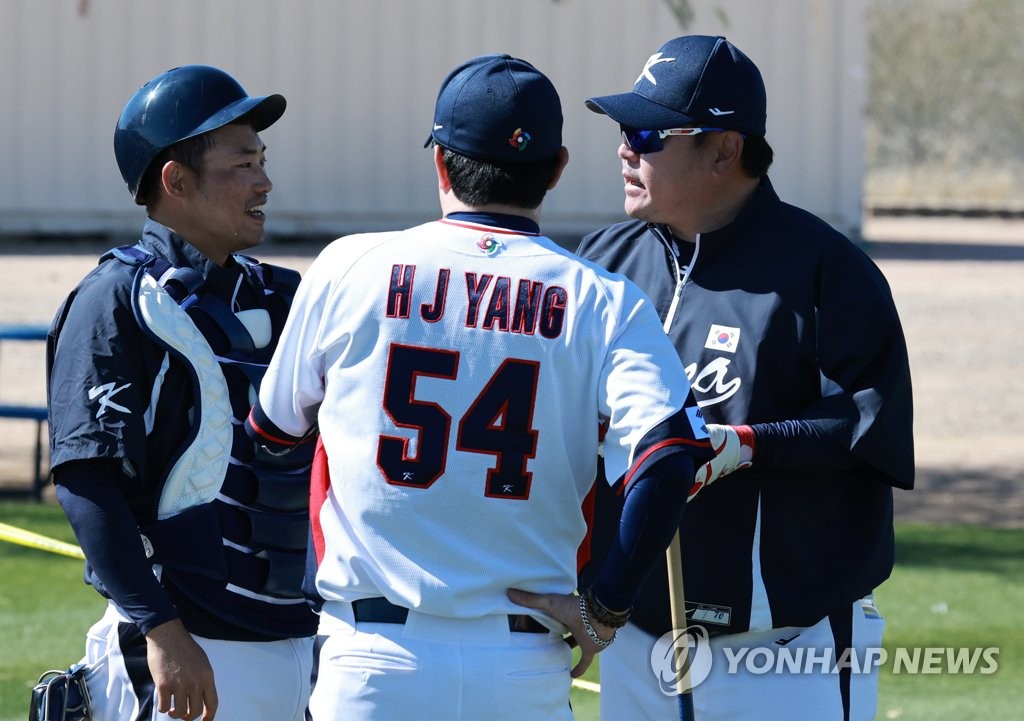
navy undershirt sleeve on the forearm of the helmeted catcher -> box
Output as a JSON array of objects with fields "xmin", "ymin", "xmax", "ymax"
[{"xmin": 53, "ymin": 459, "xmax": 178, "ymax": 634}]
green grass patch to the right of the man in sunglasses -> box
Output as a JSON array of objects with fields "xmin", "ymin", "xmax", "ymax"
[{"xmin": 876, "ymin": 524, "xmax": 1024, "ymax": 721}]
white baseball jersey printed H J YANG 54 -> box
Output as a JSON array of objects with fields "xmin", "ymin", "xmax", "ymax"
[{"xmin": 259, "ymin": 219, "xmax": 707, "ymax": 618}]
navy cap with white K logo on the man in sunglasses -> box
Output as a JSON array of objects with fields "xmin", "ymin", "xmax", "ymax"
[{"xmin": 587, "ymin": 35, "xmax": 767, "ymax": 137}]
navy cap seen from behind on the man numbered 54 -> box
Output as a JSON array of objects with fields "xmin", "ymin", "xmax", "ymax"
[{"xmin": 424, "ymin": 54, "xmax": 562, "ymax": 163}]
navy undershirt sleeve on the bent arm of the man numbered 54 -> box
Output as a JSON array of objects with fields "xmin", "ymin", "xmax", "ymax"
[{"xmin": 594, "ymin": 453, "xmax": 695, "ymax": 610}]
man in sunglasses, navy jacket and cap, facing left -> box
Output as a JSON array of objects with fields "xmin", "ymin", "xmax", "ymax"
[{"xmin": 578, "ymin": 36, "xmax": 913, "ymax": 721}]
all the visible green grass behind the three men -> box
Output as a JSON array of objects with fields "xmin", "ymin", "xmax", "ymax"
[{"xmin": 0, "ymin": 501, "xmax": 1024, "ymax": 721}]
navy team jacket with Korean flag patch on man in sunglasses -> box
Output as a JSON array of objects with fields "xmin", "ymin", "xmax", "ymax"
[{"xmin": 577, "ymin": 177, "xmax": 914, "ymax": 636}]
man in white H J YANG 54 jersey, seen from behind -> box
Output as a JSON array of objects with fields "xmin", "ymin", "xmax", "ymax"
[{"xmin": 248, "ymin": 55, "xmax": 713, "ymax": 721}]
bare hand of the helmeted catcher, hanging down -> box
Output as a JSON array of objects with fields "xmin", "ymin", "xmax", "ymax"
[{"xmin": 145, "ymin": 620, "xmax": 217, "ymax": 721}]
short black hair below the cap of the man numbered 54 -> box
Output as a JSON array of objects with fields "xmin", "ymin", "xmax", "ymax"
[{"xmin": 441, "ymin": 145, "xmax": 559, "ymax": 209}]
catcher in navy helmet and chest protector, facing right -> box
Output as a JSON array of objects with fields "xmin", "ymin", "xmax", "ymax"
[{"xmin": 47, "ymin": 66, "xmax": 316, "ymax": 721}]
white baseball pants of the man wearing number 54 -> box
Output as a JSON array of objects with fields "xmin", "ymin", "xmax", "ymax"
[{"xmin": 303, "ymin": 602, "xmax": 572, "ymax": 721}]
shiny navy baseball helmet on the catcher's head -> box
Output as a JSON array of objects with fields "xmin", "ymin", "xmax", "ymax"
[{"xmin": 114, "ymin": 66, "xmax": 285, "ymax": 204}]
